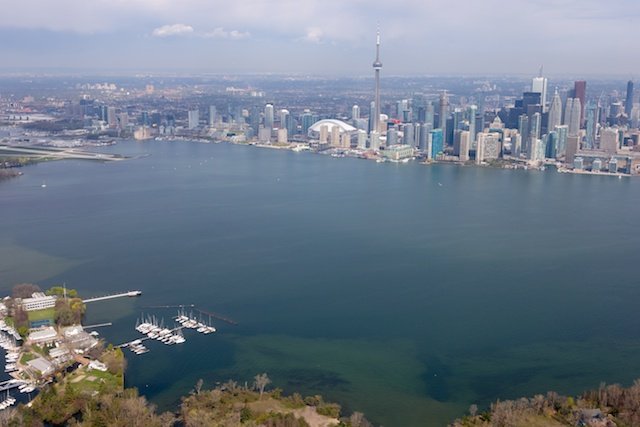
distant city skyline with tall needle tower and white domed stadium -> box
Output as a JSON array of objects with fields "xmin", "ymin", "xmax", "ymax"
[{"xmin": 0, "ymin": 33, "xmax": 640, "ymax": 176}]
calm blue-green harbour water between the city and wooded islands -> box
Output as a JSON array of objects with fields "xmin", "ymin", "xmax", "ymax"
[{"xmin": 0, "ymin": 142, "xmax": 640, "ymax": 426}]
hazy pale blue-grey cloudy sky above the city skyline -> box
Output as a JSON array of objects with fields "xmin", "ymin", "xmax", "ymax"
[{"xmin": 0, "ymin": 0, "xmax": 640, "ymax": 77}]
